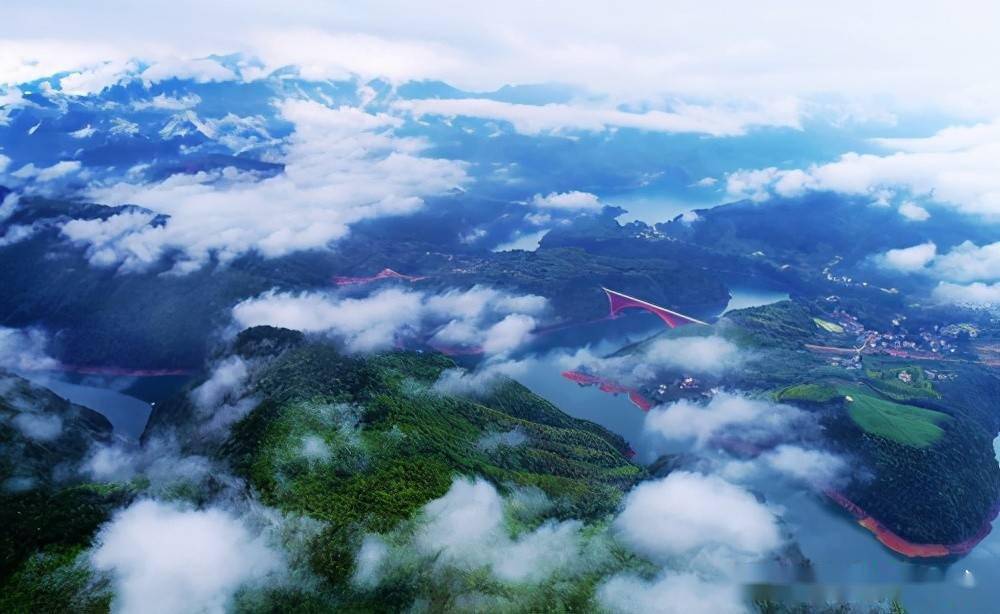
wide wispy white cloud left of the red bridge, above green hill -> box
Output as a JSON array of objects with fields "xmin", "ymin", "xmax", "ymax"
[{"xmin": 233, "ymin": 286, "xmax": 547, "ymax": 354}]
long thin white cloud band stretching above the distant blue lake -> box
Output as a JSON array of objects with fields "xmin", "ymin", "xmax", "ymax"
[{"xmin": 394, "ymin": 98, "xmax": 800, "ymax": 136}]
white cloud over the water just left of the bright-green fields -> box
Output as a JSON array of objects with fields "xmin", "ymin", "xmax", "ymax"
[{"xmin": 643, "ymin": 392, "xmax": 809, "ymax": 447}]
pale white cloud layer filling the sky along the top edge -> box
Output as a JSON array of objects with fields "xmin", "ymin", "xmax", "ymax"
[{"xmin": 9, "ymin": 0, "xmax": 1000, "ymax": 118}]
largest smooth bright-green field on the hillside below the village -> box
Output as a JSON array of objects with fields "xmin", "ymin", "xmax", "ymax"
[{"xmin": 839, "ymin": 388, "xmax": 951, "ymax": 448}]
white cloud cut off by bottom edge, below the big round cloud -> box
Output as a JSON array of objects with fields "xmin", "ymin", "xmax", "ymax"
[{"xmin": 597, "ymin": 573, "xmax": 747, "ymax": 614}]
